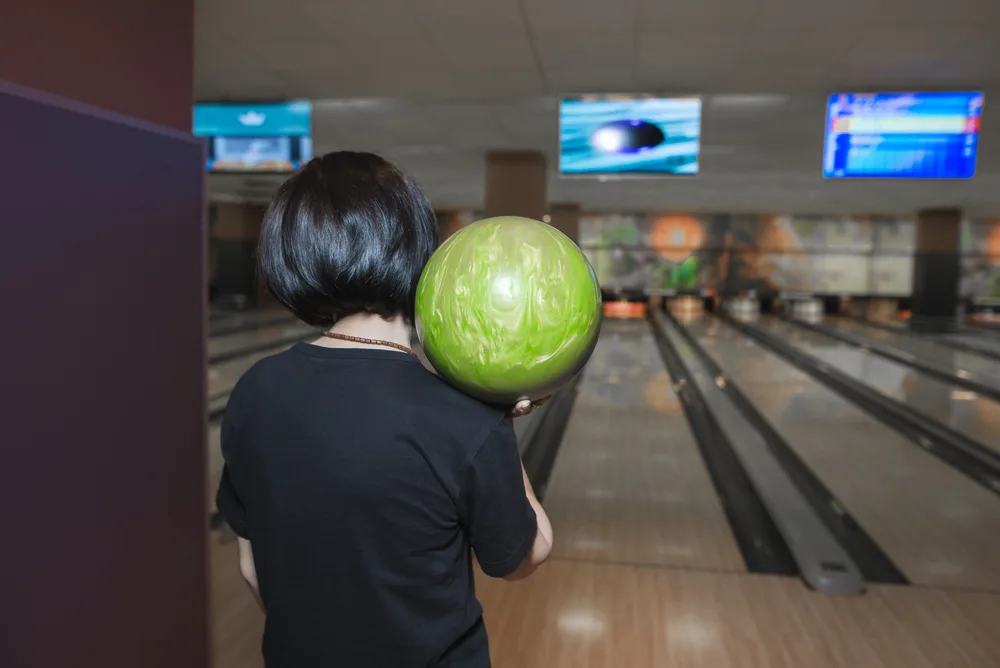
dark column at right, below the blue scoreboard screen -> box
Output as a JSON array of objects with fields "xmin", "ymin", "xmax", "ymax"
[{"xmin": 910, "ymin": 209, "xmax": 962, "ymax": 332}]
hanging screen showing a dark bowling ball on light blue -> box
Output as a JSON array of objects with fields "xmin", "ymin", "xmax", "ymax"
[{"xmin": 559, "ymin": 97, "xmax": 701, "ymax": 176}]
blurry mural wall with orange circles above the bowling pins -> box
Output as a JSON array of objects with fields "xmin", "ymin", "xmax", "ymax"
[{"xmin": 580, "ymin": 213, "xmax": 1000, "ymax": 297}]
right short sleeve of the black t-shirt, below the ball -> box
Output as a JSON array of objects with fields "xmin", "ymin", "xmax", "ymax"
[{"xmin": 465, "ymin": 420, "xmax": 538, "ymax": 578}]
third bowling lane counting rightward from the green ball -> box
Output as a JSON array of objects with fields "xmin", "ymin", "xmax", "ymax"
[{"xmin": 754, "ymin": 317, "xmax": 1000, "ymax": 451}]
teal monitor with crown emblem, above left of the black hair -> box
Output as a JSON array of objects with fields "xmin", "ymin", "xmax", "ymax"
[{"xmin": 194, "ymin": 101, "xmax": 312, "ymax": 173}]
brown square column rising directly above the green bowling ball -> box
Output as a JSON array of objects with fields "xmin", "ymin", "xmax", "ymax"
[{"xmin": 484, "ymin": 151, "xmax": 548, "ymax": 220}]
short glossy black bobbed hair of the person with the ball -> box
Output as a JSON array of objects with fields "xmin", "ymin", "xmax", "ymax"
[{"xmin": 258, "ymin": 151, "xmax": 438, "ymax": 327}]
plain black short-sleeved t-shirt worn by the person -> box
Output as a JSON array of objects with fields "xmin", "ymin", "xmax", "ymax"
[{"xmin": 217, "ymin": 343, "xmax": 537, "ymax": 668}]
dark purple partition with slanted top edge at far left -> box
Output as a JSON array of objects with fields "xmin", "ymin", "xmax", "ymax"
[{"xmin": 0, "ymin": 83, "xmax": 208, "ymax": 668}]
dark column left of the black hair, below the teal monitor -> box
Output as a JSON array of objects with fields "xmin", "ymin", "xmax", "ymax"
[{"xmin": 209, "ymin": 202, "xmax": 268, "ymax": 308}]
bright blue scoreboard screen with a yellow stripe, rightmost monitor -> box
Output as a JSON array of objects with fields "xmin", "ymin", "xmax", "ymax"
[{"xmin": 823, "ymin": 93, "xmax": 983, "ymax": 179}]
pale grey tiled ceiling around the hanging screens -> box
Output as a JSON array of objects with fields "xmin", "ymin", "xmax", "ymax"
[{"xmin": 196, "ymin": 0, "xmax": 1000, "ymax": 213}]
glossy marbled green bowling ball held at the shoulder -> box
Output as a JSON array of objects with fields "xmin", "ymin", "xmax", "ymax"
[{"xmin": 415, "ymin": 216, "xmax": 601, "ymax": 404}]
